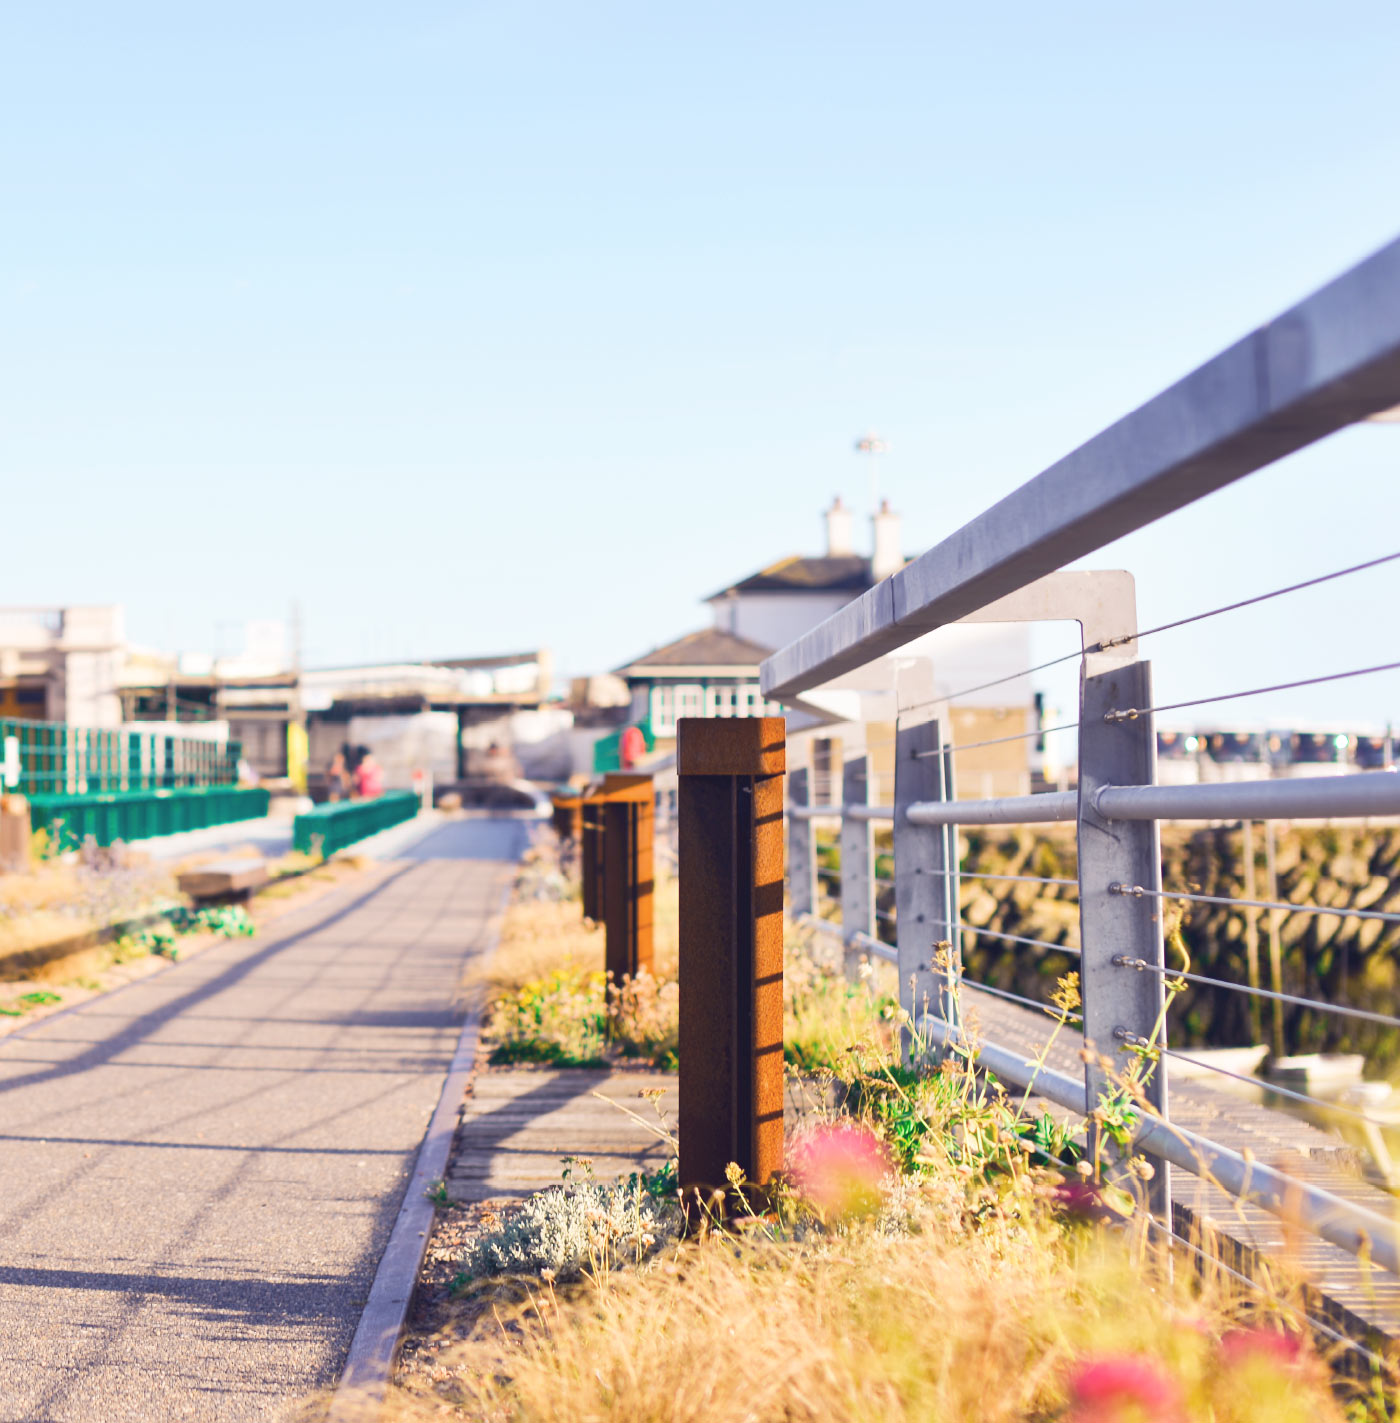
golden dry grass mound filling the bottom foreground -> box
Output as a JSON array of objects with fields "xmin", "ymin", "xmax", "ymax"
[{"xmin": 390, "ymin": 1177, "xmax": 1380, "ymax": 1423}]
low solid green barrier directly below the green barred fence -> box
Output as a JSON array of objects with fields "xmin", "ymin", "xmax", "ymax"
[{"xmin": 28, "ymin": 785, "xmax": 269, "ymax": 850}]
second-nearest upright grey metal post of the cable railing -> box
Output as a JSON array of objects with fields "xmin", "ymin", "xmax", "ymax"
[{"xmin": 895, "ymin": 700, "xmax": 962, "ymax": 1062}]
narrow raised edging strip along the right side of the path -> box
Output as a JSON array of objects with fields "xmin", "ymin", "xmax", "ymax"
[{"xmin": 326, "ymin": 875, "xmax": 515, "ymax": 1423}]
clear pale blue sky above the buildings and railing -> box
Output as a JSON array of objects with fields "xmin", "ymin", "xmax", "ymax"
[{"xmin": 0, "ymin": 0, "xmax": 1400, "ymax": 719}]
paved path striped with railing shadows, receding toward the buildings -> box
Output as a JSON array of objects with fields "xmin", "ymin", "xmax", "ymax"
[{"xmin": 0, "ymin": 820, "xmax": 525, "ymax": 1423}]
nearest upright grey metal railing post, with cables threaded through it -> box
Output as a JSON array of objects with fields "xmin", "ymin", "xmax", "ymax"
[{"xmin": 1077, "ymin": 662, "xmax": 1171, "ymax": 1220}]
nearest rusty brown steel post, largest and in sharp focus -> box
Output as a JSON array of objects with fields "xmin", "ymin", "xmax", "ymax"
[{"xmin": 676, "ymin": 717, "xmax": 787, "ymax": 1188}]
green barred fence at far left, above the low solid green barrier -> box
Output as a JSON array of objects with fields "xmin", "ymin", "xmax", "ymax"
[{"xmin": 0, "ymin": 719, "xmax": 242, "ymax": 795}]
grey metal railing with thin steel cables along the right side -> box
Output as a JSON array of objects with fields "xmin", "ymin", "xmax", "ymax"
[{"xmin": 761, "ymin": 230, "xmax": 1400, "ymax": 1272}]
